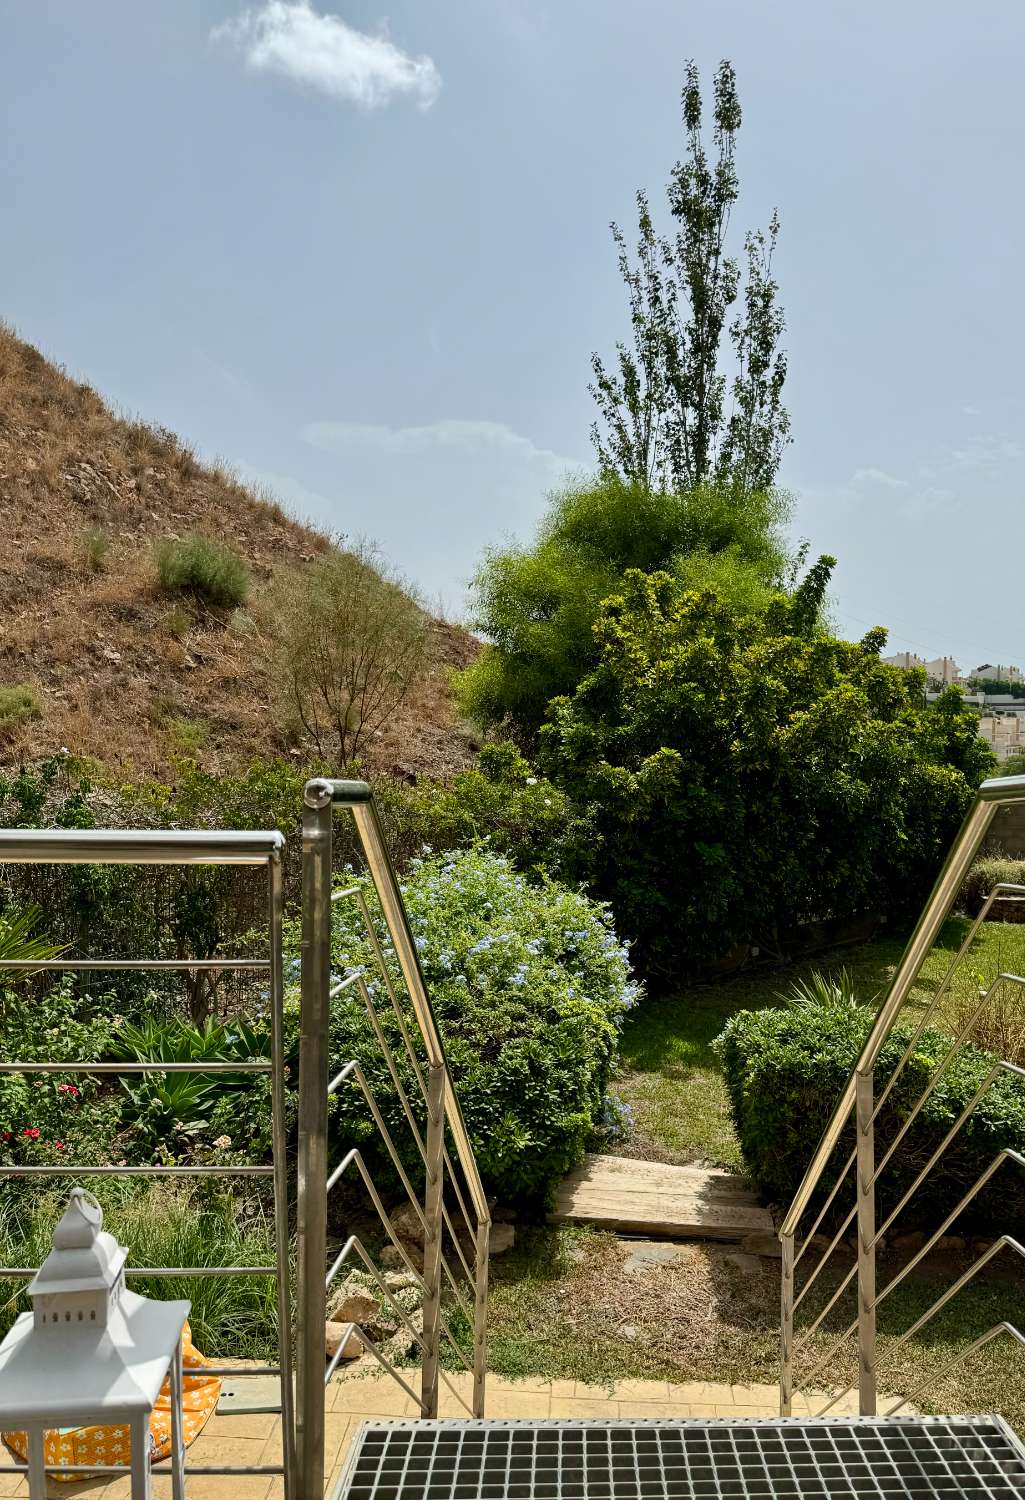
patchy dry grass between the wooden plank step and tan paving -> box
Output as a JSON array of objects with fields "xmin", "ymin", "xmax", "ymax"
[{"xmin": 488, "ymin": 1226, "xmax": 1025, "ymax": 1430}]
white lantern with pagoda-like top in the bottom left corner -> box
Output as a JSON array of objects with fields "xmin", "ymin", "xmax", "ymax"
[{"xmin": 0, "ymin": 1188, "xmax": 191, "ymax": 1500}]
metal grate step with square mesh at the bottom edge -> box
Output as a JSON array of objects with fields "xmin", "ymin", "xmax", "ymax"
[{"xmin": 335, "ymin": 1416, "xmax": 1025, "ymax": 1500}]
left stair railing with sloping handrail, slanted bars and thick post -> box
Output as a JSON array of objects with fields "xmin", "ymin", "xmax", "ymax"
[{"xmin": 296, "ymin": 779, "xmax": 491, "ymax": 1500}]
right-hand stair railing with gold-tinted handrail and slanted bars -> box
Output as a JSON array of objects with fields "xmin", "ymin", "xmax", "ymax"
[{"xmin": 779, "ymin": 776, "xmax": 1025, "ymax": 1415}]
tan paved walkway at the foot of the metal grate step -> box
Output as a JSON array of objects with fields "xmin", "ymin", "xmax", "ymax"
[{"xmin": 0, "ymin": 1371, "xmax": 876, "ymax": 1500}]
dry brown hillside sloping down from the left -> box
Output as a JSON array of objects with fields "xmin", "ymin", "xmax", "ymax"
[{"xmin": 0, "ymin": 327, "xmax": 476, "ymax": 776}]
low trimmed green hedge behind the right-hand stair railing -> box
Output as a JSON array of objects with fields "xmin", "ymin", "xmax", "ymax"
[{"xmin": 716, "ymin": 1007, "xmax": 1025, "ymax": 1235}]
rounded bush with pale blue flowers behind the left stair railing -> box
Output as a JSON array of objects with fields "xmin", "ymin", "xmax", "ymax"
[{"xmin": 292, "ymin": 846, "xmax": 639, "ymax": 1206}]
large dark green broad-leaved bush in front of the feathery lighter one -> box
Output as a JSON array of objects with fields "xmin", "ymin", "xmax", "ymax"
[{"xmin": 539, "ymin": 558, "xmax": 992, "ymax": 978}]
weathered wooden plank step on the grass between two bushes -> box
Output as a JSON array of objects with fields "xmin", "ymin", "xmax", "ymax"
[{"xmin": 551, "ymin": 1155, "xmax": 773, "ymax": 1242}]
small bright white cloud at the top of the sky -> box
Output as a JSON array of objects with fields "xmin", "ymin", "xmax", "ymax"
[{"xmin": 210, "ymin": 0, "xmax": 441, "ymax": 110}]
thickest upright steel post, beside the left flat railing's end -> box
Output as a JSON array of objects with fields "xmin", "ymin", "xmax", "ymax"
[{"xmin": 296, "ymin": 782, "xmax": 332, "ymax": 1500}]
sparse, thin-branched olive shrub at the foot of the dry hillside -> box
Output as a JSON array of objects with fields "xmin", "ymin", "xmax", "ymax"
[{"xmin": 267, "ymin": 546, "xmax": 429, "ymax": 767}]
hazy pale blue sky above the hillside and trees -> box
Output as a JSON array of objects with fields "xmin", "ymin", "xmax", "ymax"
[{"xmin": 0, "ymin": 0, "xmax": 1025, "ymax": 668}]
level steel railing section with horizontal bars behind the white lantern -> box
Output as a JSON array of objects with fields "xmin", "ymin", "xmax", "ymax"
[{"xmin": 0, "ymin": 828, "xmax": 300, "ymax": 1500}]
